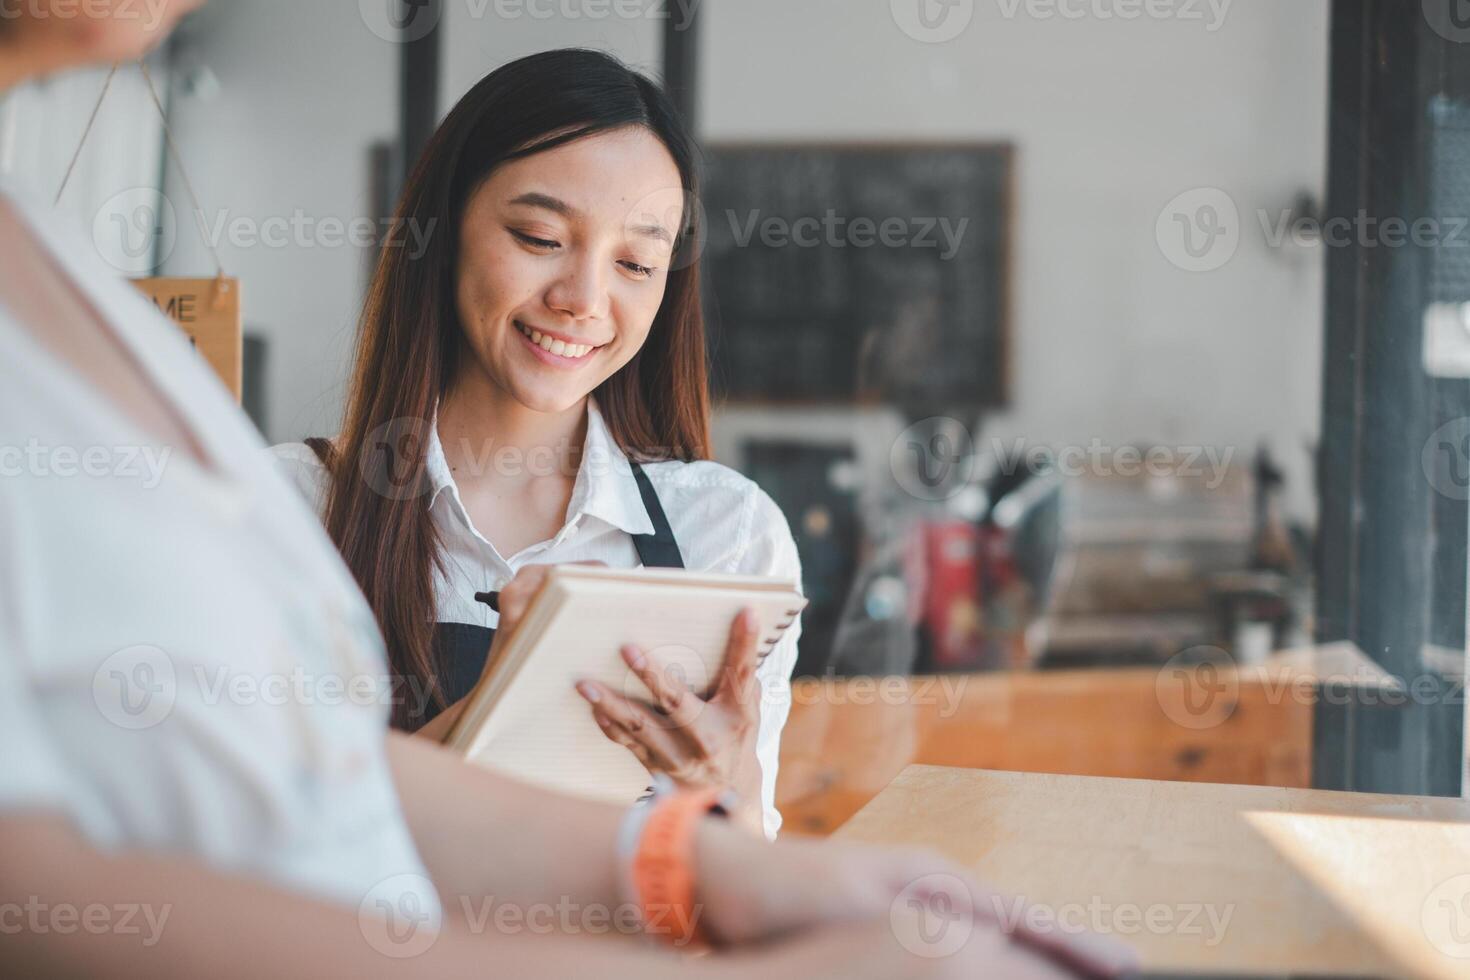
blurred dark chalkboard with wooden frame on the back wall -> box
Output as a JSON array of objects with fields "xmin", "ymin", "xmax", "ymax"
[{"xmin": 703, "ymin": 144, "xmax": 1013, "ymax": 410}]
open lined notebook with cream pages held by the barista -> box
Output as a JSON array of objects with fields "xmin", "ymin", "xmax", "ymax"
[{"xmin": 445, "ymin": 566, "xmax": 807, "ymax": 804}]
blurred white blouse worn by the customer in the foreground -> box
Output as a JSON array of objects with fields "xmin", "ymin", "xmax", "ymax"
[{"xmin": 0, "ymin": 179, "xmax": 440, "ymax": 917}]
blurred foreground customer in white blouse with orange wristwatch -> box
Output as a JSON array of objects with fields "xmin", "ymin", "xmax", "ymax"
[{"xmin": 0, "ymin": 0, "xmax": 1125, "ymax": 980}]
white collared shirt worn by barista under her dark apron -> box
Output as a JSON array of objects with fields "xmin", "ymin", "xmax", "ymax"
[{"xmin": 273, "ymin": 398, "xmax": 801, "ymax": 837}]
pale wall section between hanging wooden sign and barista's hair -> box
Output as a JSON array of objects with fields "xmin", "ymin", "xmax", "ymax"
[{"xmin": 166, "ymin": 0, "xmax": 398, "ymax": 441}]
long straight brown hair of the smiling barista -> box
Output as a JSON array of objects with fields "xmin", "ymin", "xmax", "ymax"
[{"xmin": 313, "ymin": 48, "xmax": 710, "ymax": 727}]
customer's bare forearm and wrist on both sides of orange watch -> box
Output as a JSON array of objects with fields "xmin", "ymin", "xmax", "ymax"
[{"xmin": 388, "ymin": 733, "xmax": 858, "ymax": 943}]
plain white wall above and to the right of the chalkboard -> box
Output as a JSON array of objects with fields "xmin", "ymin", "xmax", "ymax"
[{"xmin": 701, "ymin": 0, "xmax": 1327, "ymax": 516}]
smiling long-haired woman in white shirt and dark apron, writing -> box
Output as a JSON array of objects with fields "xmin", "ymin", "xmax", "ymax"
[{"xmin": 276, "ymin": 50, "xmax": 801, "ymax": 837}]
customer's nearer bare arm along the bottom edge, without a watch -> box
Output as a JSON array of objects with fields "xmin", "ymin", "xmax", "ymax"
[{"xmin": 0, "ymin": 814, "xmax": 1105, "ymax": 980}]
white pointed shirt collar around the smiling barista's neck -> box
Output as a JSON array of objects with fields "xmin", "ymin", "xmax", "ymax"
[{"xmin": 425, "ymin": 398, "xmax": 654, "ymax": 535}]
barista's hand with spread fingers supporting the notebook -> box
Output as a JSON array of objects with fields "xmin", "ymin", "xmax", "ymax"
[{"xmin": 578, "ymin": 610, "xmax": 760, "ymax": 821}]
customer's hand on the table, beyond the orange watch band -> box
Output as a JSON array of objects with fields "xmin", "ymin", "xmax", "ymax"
[{"xmin": 695, "ymin": 818, "xmax": 1136, "ymax": 977}]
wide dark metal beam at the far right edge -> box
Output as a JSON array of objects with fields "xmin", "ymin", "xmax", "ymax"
[{"xmin": 1313, "ymin": 0, "xmax": 1470, "ymax": 795}]
